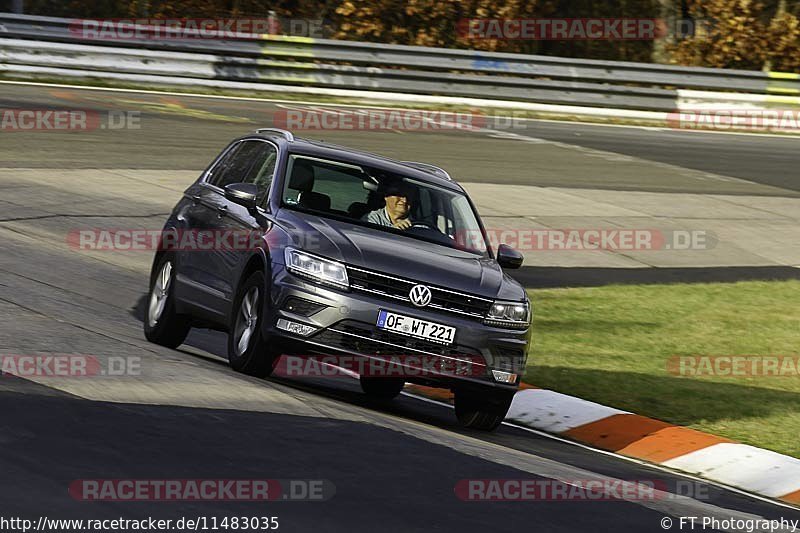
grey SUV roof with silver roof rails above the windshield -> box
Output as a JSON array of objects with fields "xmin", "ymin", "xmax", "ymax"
[{"xmin": 247, "ymin": 129, "xmax": 464, "ymax": 192}]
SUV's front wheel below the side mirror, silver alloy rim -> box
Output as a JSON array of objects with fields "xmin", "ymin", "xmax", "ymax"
[{"xmin": 228, "ymin": 271, "xmax": 280, "ymax": 378}]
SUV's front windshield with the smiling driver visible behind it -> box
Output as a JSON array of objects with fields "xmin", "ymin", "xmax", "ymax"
[{"xmin": 282, "ymin": 154, "xmax": 488, "ymax": 255}]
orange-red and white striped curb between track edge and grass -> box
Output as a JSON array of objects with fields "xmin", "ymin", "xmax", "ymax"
[{"xmin": 407, "ymin": 385, "xmax": 800, "ymax": 505}]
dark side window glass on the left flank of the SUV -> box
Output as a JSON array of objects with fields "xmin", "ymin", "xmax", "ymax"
[{"xmin": 207, "ymin": 141, "xmax": 278, "ymax": 204}]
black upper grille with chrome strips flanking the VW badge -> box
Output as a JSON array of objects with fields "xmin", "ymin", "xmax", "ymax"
[{"xmin": 347, "ymin": 266, "xmax": 492, "ymax": 319}]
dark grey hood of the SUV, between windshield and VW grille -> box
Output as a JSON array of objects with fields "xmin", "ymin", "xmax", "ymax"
[{"xmin": 279, "ymin": 209, "xmax": 524, "ymax": 300}]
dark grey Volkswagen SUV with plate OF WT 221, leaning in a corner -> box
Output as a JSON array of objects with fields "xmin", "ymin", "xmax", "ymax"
[{"xmin": 144, "ymin": 128, "xmax": 531, "ymax": 430}]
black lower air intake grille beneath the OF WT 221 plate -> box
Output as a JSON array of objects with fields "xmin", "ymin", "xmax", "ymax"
[{"xmin": 309, "ymin": 320, "xmax": 485, "ymax": 366}]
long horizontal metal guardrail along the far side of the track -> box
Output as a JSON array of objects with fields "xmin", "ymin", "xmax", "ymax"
[{"xmin": 0, "ymin": 13, "xmax": 800, "ymax": 111}]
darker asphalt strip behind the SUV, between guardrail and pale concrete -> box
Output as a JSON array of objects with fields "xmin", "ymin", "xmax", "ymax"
[{"xmin": 0, "ymin": 85, "xmax": 800, "ymax": 196}]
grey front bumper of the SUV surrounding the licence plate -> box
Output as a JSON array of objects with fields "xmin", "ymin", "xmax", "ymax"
[{"xmin": 263, "ymin": 264, "xmax": 531, "ymax": 389}]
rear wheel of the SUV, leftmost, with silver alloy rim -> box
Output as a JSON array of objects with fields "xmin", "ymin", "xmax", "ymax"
[{"xmin": 144, "ymin": 253, "xmax": 192, "ymax": 348}]
